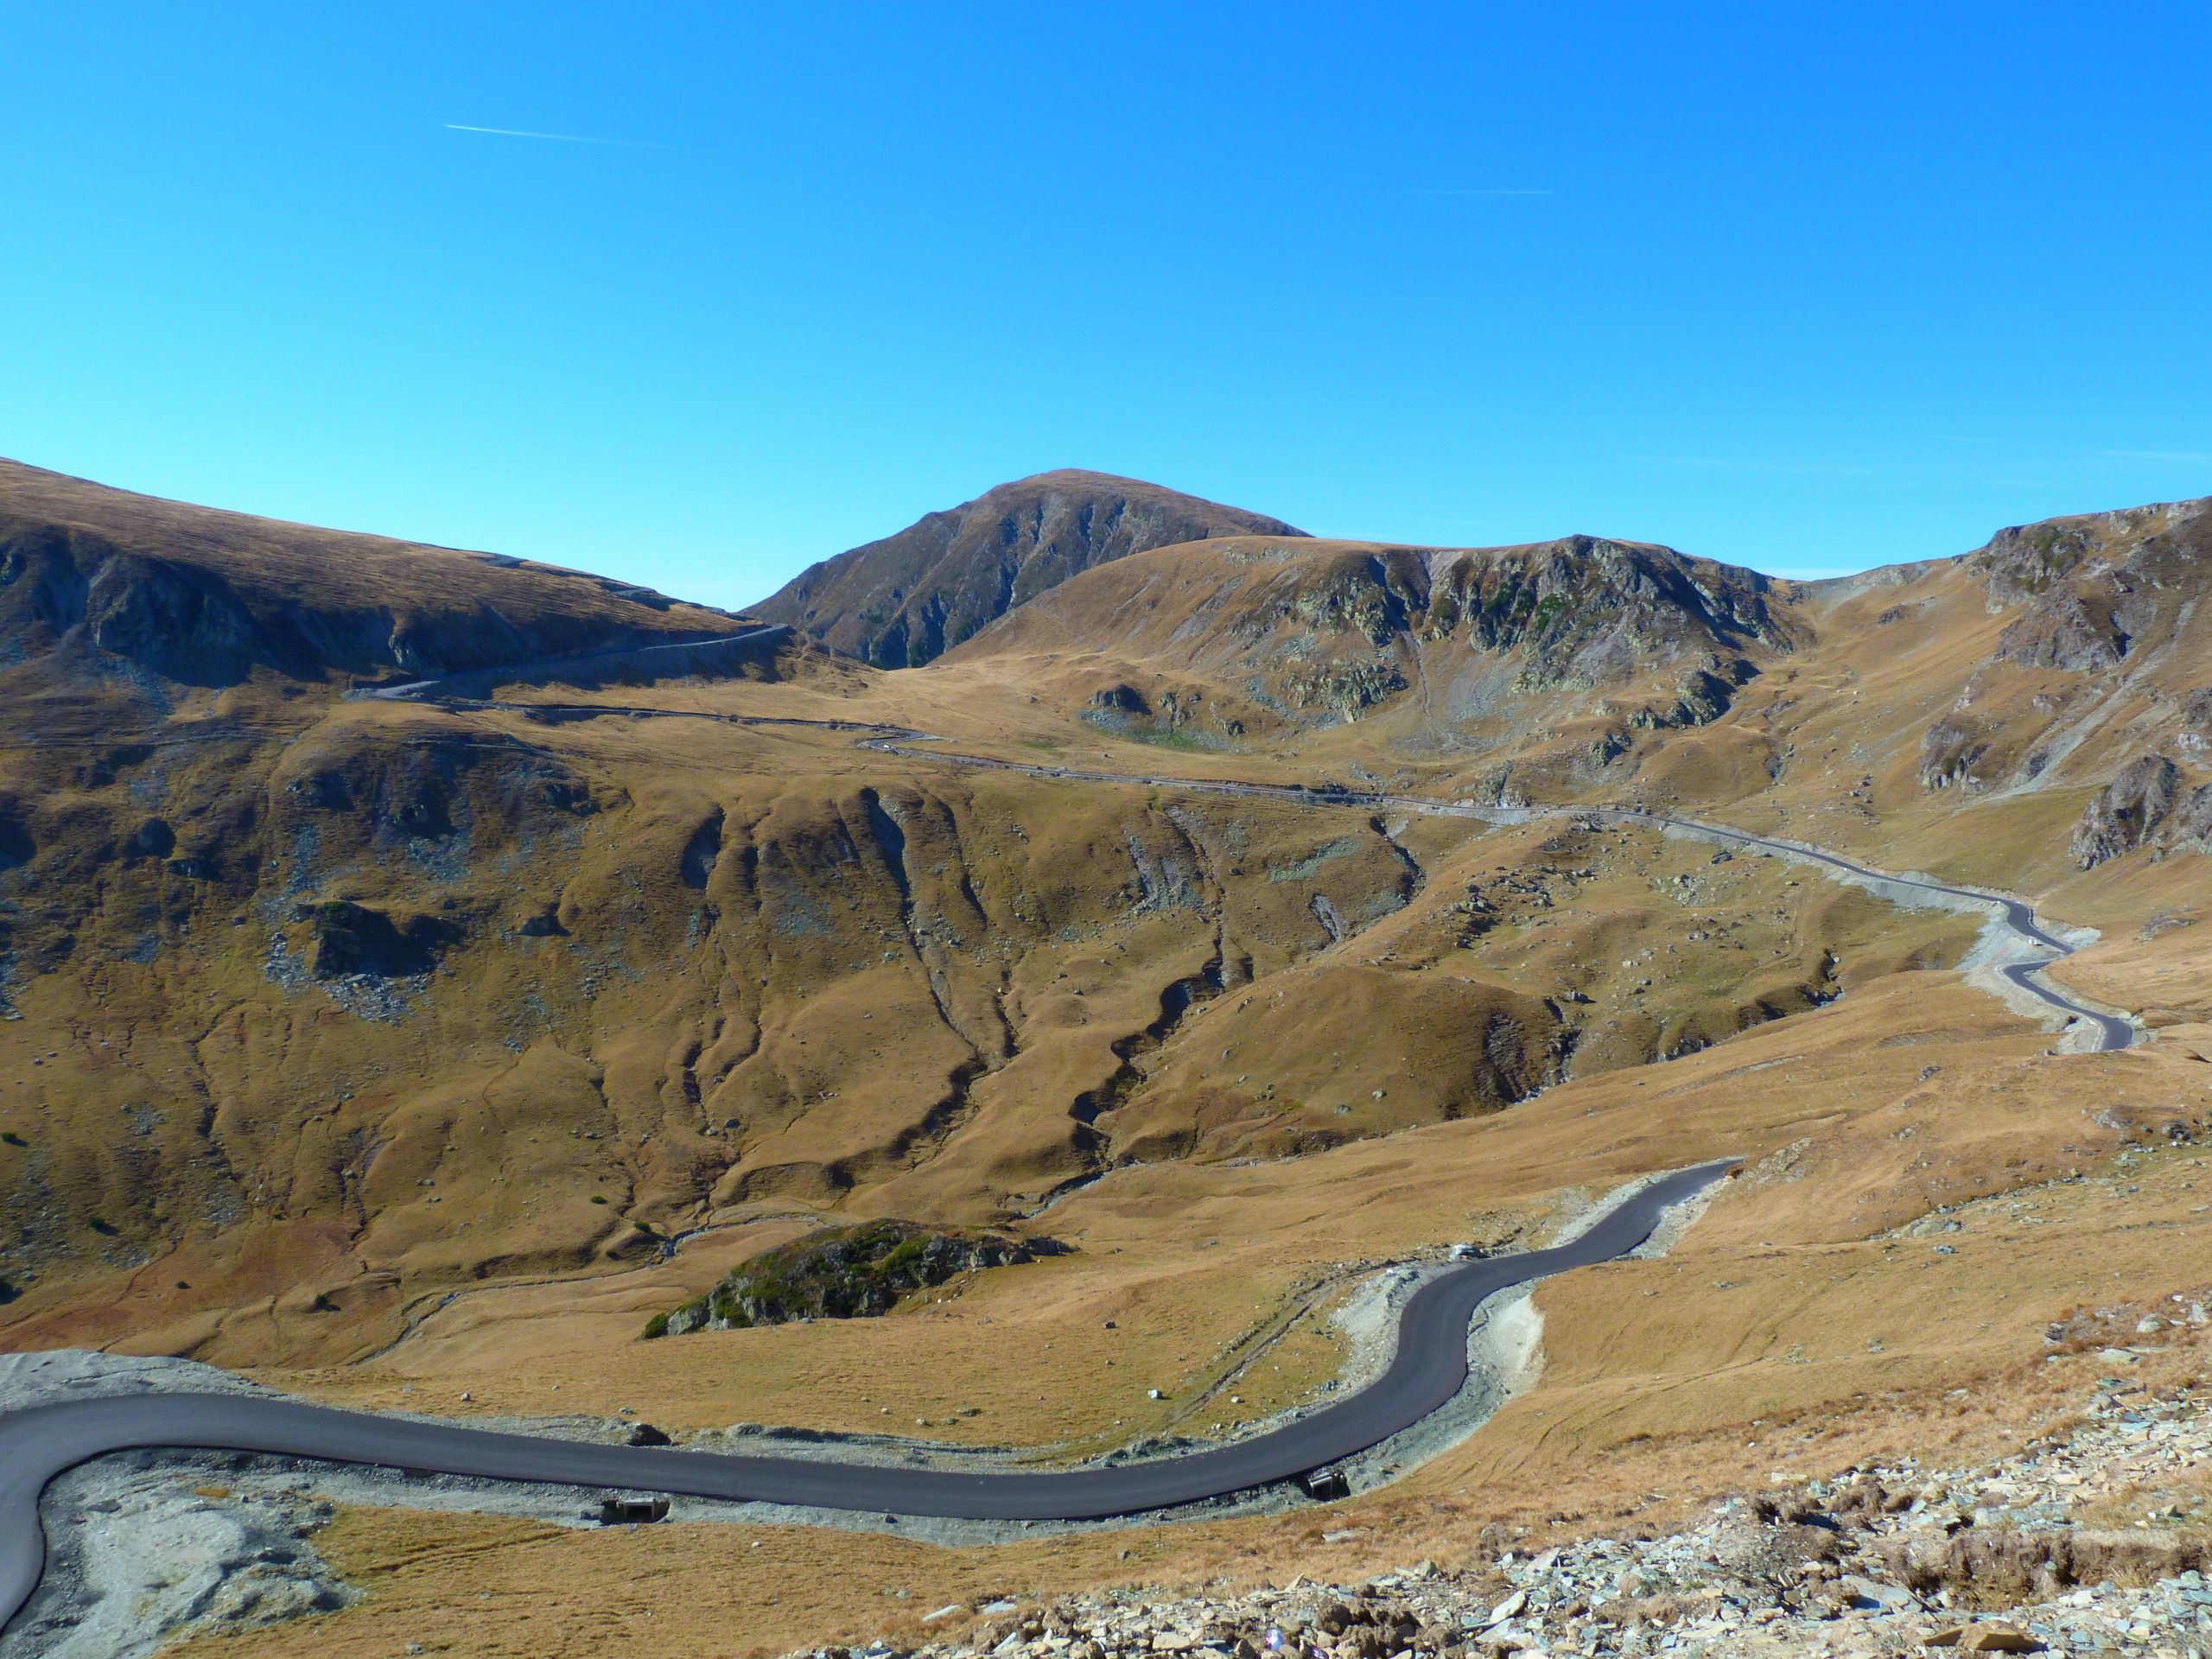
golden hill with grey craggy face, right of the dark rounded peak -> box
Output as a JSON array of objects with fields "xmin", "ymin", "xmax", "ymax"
[{"xmin": 956, "ymin": 536, "xmax": 1794, "ymax": 739}]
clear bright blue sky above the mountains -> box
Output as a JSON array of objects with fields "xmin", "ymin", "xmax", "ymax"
[{"xmin": 0, "ymin": 0, "xmax": 2212, "ymax": 606}]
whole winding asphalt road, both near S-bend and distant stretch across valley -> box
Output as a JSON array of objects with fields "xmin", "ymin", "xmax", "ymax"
[{"xmin": 0, "ymin": 708, "xmax": 2134, "ymax": 1628}]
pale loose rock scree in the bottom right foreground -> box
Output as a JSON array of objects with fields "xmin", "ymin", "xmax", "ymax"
[{"xmin": 830, "ymin": 1380, "xmax": 2212, "ymax": 1659}]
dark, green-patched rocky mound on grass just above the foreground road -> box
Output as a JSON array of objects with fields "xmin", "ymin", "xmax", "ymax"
[{"xmin": 646, "ymin": 1221, "xmax": 1066, "ymax": 1336}]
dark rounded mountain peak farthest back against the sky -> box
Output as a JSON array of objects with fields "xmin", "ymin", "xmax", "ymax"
[{"xmin": 759, "ymin": 471, "xmax": 1303, "ymax": 668}]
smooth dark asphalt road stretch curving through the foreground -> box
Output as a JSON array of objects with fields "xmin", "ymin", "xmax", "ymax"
[{"xmin": 0, "ymin": 1159, "xmax": 1734, "ymax": 1628}]
